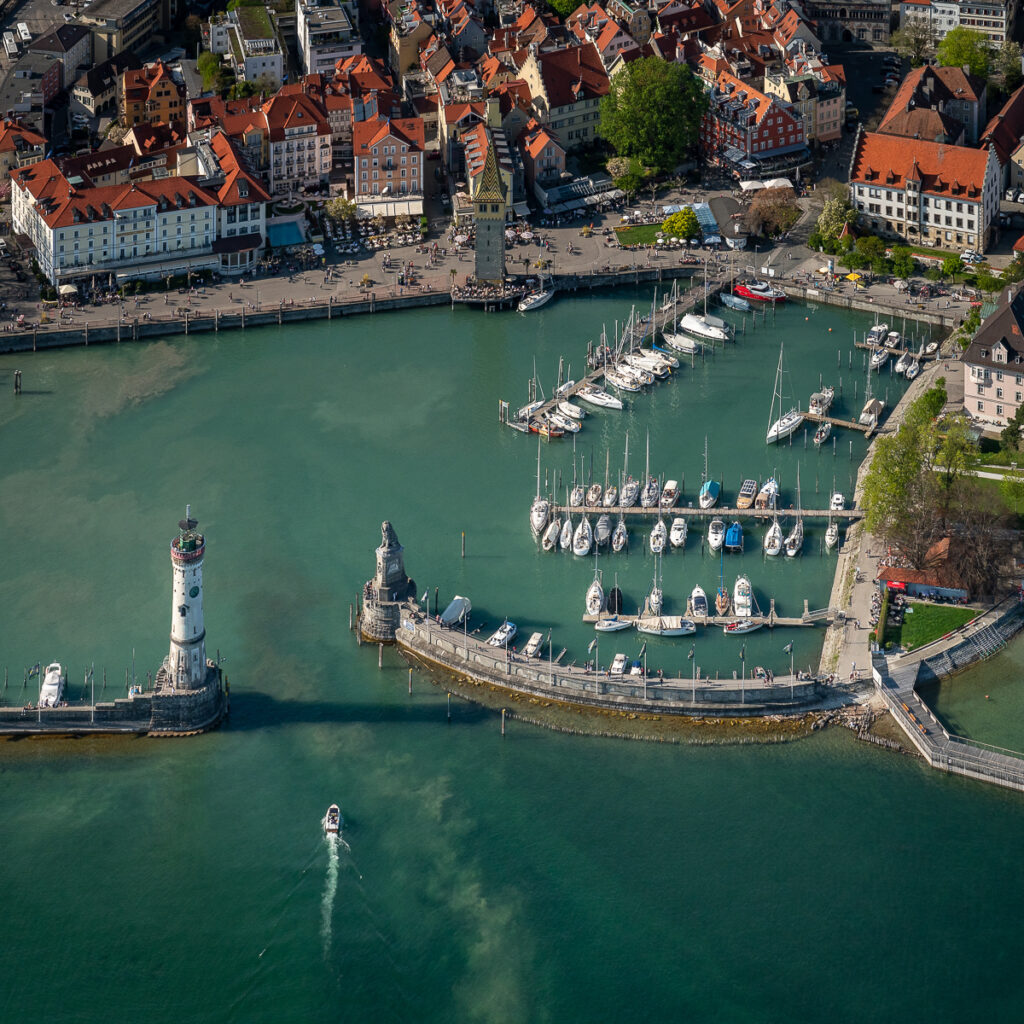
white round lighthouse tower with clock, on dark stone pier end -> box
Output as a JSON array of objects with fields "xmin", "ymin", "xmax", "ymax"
[{"xmin": 164, "ymin": 505, "xmax": 207, "ymax": 690}]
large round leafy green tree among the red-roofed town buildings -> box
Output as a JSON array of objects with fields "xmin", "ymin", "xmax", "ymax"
[{"xmin": 598, "ymin": 57, "xmax": 708, "ymax": 171}]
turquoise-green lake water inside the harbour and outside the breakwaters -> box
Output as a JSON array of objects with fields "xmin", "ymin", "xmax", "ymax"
[{"xmin": 0, "ymin": 294, "xmax": 1024, "ymax": 1022}]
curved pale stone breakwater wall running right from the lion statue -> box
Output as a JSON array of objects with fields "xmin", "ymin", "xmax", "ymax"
[{"xmin": 395, "ymin": 602, "xmax": 824, "ymax": 717}]
